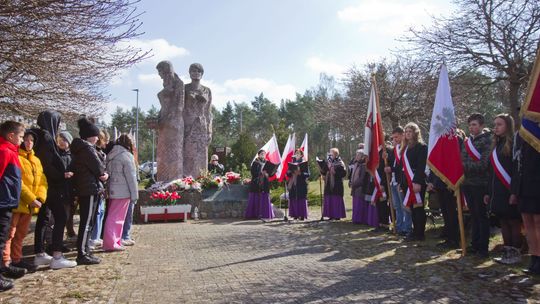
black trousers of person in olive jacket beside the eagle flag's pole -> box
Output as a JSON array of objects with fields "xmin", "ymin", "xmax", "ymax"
[{"xmin": 462, "ymin": 185, "xmax": 489, "ymax": 253}]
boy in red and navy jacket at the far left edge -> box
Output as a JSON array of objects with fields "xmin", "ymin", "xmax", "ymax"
[{"xmin": 0, "ymin": 121, "xmax": 26, "ymax": 291}]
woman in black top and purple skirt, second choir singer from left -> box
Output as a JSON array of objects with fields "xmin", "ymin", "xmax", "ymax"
[{"xmin": 287, "ymin": 149, "xmax": 309, "ymax": 221}]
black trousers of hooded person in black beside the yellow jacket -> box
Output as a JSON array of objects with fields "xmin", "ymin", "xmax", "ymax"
[{"xmin": 46, "ymin": 191, "xmax": 71, "ymax": 251}]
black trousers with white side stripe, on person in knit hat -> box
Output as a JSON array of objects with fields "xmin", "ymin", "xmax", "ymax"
[{"xmin": 77, "ymin": 195, "xmax": 99, "ymax": 258}]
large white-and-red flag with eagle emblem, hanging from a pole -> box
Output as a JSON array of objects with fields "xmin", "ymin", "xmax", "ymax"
[{"xmin": 427, "ymin": 64, "xmax": 463, "ymax": 190}]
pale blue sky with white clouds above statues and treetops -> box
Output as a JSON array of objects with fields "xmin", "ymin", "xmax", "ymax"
[{"xmin": 105, "ymin": 0, "xmax": 452, "ymax": 120}]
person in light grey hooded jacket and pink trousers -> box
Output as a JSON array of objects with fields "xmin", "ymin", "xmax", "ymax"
[{"xmin": 103, "ymin": 134, "xmax": 139, "ymax": 251}]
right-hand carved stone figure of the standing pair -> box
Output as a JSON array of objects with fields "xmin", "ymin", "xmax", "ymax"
[{"xmin": 184, "ymin": 63, "xmax": 212, "ymax": 177}]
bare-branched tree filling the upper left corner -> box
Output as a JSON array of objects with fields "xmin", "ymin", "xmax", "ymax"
[{"xmin": 0, "ymin": 0, "xmax": 148, "ymax": 114}]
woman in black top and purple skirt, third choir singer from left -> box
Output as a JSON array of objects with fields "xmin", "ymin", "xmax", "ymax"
[{"xmin": 322, "ymin": 148, "xmax": 347, "ymax": 220}]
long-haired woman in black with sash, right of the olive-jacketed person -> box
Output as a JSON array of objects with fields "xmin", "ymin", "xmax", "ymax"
[{"xmin": 484, "ymin": 114, "xmax": 523, "ymax": 264}]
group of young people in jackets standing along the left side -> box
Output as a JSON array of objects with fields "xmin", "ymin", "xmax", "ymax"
[{"xmin": 0, "ymin": 111, "xmax": 138, "ymax": 291}]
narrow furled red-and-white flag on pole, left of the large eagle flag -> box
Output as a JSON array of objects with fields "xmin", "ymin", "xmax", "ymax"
[{"xmin": 364, "ymin": 79, "xmax": 384, "ymax": 202}]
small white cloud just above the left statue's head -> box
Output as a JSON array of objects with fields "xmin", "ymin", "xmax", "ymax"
[{"xmin": 125, "ymin": 38, "xmax": 189, "ymax": 63}]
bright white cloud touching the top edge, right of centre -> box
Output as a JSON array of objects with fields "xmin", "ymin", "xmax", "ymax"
[{"xmin": 337, "ymin": 0, "xmax": 442, "ymax": 36}]
